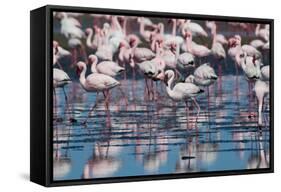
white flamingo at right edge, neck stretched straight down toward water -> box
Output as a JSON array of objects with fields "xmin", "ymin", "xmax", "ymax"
[{"xmin": 253, "ymin": 80, "xmax": 269, "ymax": 126}]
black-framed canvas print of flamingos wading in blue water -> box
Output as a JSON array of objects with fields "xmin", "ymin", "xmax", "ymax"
[{"xmin": 30, "ymin": 5, "xmax": 274, "ymax": 186}]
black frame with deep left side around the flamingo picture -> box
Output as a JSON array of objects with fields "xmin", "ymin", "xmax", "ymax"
[{"xmin": 30, "ymin": 5, "xmax": 274, "ymax": 187}]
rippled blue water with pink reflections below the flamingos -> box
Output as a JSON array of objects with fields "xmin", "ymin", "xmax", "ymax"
[{"xmin": 53, "ymin": 76, "xmax": 270, "ymax": 180}]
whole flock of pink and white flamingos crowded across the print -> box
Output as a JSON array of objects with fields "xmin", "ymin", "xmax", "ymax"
[{"xmin": 53, "ymin": 12, "xmax": 270, "ymax": 126}]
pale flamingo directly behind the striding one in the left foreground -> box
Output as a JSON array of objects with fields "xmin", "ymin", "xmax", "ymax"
[{"xmin": 89, "ymin": 54, "xmax": 125, "ymax": 77}]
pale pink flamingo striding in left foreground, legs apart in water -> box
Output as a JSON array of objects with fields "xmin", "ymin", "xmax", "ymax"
[{"xmin": 77, "ymin": 61, "xmax": 120, "ymax": 124}]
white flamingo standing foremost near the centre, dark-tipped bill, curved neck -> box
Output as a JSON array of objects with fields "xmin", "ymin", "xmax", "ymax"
[{"xmin": 164, "ymin": 70, "xmax": 204, "ymax": 121}]
